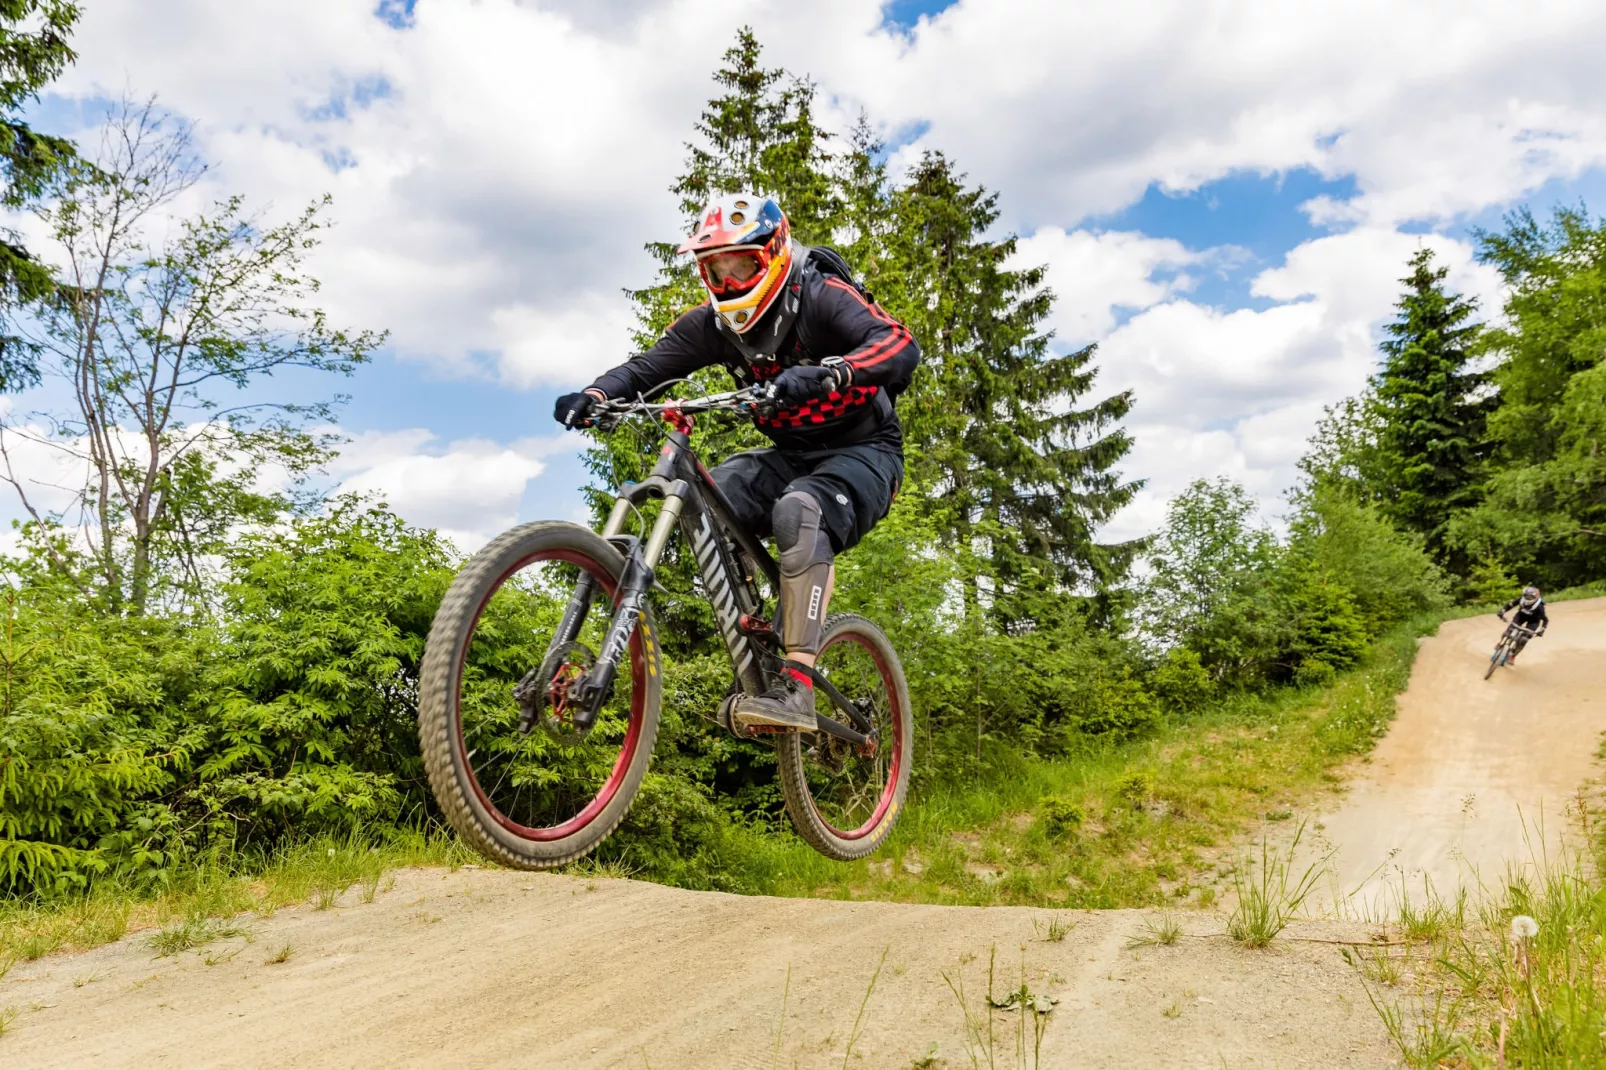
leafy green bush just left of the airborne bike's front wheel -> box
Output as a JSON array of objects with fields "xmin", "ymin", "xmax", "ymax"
[{"xmin": 198, "ymin": 498, "xmax": 453, "ymax": 835}]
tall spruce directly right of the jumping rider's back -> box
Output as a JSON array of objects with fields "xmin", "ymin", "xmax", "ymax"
[{"xmin": 877, "ymin": 153, "xmax": 1140, "ymax": 625}]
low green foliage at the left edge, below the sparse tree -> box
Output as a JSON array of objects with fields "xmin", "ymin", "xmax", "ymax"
[{"xmin": 0, "ymin": 585, "xmax": 210, "ymax": 892}]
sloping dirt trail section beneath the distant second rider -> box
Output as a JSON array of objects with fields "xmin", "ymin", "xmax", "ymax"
[{"xmin": 1322, "ymin": 598, "xmax": 1606, "ymax": 916}]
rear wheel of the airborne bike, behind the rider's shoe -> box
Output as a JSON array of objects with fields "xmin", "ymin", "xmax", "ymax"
[{"xmin": 776, "ymin": 614, "xmax": 914, "ymax": 861}]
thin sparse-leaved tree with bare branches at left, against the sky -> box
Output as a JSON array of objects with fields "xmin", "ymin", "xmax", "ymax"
[{"xmin": 0, "ymin": 104, "xmax": 382, "ymax": 615}]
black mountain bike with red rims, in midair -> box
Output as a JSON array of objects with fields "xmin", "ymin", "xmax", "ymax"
[{"xmin": 419, "ymin": 387, "xmax": 914, "ymax": 869}]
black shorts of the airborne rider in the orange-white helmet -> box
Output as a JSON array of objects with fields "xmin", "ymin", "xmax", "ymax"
[{"xmin": 711, "ymin": 442, "xmax": 903, "ymax": 554}]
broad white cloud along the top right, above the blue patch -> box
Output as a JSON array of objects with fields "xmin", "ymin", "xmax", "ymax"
[{"xmin": 860, "ymin": 0, "xmax": 1606, "ymax": 227}]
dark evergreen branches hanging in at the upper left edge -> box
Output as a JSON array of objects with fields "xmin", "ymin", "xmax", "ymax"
[{"xmin": 0, "ymin": 0, "xmax": 79, "ymax": 383}]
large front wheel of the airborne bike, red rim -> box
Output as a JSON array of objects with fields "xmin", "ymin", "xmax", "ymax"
[{"xmin": 418, "ymin": 521, "xmax": 662, "ymax": 869}]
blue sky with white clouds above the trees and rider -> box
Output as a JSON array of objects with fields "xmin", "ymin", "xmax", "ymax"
[{"xmin": 0, "ymin": 0, "xmax": 1606, "ymax": 548}]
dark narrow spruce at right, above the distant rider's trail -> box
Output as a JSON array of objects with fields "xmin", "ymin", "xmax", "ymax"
[{"xmin": 1373, "ymin": 249, "xmax": 1489, "ymax": 567}]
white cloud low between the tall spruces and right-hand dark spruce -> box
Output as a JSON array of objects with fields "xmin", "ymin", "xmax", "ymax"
[{"xmin": 1099, "ymin": 228, "xmax": 1498, "ymax": 538}]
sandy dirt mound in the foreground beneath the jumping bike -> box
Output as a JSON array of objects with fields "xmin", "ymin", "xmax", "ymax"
[{"xmin": 0, "ymin": 871, "xmax": 1392, "ymax": 1070}]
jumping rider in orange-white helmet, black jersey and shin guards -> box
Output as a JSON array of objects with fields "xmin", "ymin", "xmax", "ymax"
[{"xmin": 552, "ymin": 193, "xmax": 920, "ymax": 729}]
